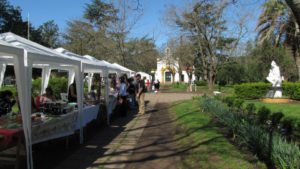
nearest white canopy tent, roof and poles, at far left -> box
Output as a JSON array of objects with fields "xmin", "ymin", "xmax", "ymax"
[{"xmin": 0, "ymin": 33, "xmax": 83, "ymax": 168}]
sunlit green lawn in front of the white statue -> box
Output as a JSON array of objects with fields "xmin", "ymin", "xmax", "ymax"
[{"xmin": 245, "ymin": 101, "xmax": 300, "ymax": 122}]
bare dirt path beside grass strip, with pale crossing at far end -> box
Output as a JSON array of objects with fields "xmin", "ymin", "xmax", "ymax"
[{"xmin": 125, "ymin": 93, "xmax": 198, "ymax": 169}]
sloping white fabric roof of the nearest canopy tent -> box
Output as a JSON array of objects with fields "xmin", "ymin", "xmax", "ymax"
[{"xmin": 0, "ymin": 32, "xmax": 79, "ymax": 67}]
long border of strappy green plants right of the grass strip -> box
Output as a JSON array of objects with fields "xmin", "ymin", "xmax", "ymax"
[{"xmin": 200, "ymin": 97, "xmax": 300, "ymax": 169}]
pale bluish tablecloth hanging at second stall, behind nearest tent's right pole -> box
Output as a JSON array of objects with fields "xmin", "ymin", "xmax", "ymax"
[{"xmin": 76, "ymin": 105, "xmax": 100, "ymax": 129}]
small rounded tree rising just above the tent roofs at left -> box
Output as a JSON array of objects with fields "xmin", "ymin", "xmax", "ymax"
[{"xmin": 38, "ymin": 20, "xmax": 59, "ymax": 48}]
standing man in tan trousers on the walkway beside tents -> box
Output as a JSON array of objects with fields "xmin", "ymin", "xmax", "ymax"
[{"xmin": 136, "ymin": 74, "xmax": 146, "ymax": 115}]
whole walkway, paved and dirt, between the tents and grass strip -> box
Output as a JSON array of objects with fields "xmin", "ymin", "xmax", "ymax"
[{"xmin": 56, "ymin": 93, "xmax": 199, "ymax": 169}]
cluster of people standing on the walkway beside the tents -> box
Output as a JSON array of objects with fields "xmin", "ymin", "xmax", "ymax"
[{"xmin": 117, "ymin": 74, "xmax": 147, "ymax": 116}]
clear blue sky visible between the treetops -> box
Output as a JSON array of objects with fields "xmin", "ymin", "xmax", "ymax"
[{"xmin": 9, "ymin": 0, "xmax": 263, "ymax": 47}]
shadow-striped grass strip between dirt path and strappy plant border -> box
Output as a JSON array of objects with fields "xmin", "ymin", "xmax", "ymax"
[{"xmin": 172, "ymin": 99, "xmax": 266, "ymax": 169}]
